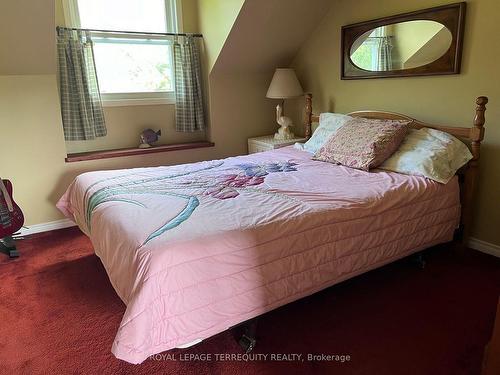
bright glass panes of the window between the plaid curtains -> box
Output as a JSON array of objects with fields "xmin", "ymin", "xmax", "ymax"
[{"xmin": 69, "ymin": 0, "xmax": 178, "ymax": 105}]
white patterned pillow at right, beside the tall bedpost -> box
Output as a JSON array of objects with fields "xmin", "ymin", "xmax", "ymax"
[{"xmin": 378, "ymin": 128, "xmax": 472, "ymax": 184}]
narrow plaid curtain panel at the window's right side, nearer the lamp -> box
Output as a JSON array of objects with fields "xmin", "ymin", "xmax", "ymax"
[{"xmin": 174, "ymin": 36, "xmax": 205, "ymax": 132}]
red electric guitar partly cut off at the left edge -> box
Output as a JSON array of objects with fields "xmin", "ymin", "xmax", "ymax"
[{"xmin": 0, "ymin": 178, "xmax": 24, "ymax": 258}]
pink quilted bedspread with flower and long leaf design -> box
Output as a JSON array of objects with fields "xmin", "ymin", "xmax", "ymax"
[{"xmin": 58, "ymin": 147, "xmax": 460, "ymax": 363}]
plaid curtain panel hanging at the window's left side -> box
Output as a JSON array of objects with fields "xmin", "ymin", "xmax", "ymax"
[{"xmin": 57, "ymin": 28, "xmax": 107, "ymax": 141}]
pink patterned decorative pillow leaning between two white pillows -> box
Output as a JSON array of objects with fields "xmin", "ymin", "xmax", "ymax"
[{"xmin": 313, "ymin": 117, "xmax": 409, "ymax": 171}]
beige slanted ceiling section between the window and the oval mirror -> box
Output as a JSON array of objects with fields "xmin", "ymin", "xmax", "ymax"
[{"xmin": 211, "ymin": 0, "xmax": 332, "ymax": 74}]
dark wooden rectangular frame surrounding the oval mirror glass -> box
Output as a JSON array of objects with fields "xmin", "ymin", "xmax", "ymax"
[{"xmin": 340, "ymin": 2, "xmax": 466, "ymax": 79}]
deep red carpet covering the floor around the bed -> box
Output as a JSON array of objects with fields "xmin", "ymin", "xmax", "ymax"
[{"xmin": 0, "ymin": 229, "xmax": 500, "ymax": 375}]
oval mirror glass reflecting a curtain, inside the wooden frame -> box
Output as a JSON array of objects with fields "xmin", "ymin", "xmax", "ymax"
[{"xmin": 350, "ymin": 20, "xmax": 453, "ymax": 72}]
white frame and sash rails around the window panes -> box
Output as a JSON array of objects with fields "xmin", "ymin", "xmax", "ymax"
[{"xmin": 63, "ymin": 0, "xmax": 183, "ymax": 107}]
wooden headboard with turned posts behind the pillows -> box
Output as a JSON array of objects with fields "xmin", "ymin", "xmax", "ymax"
[{"xmin": 304, "ymin": 94, "xmax": 488, "ymax": 243}]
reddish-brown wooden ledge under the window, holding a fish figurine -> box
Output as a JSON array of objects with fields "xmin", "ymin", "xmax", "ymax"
[{"xmin": 65, "ymin": 141, "xmax": 215, "ymax": 163}]
